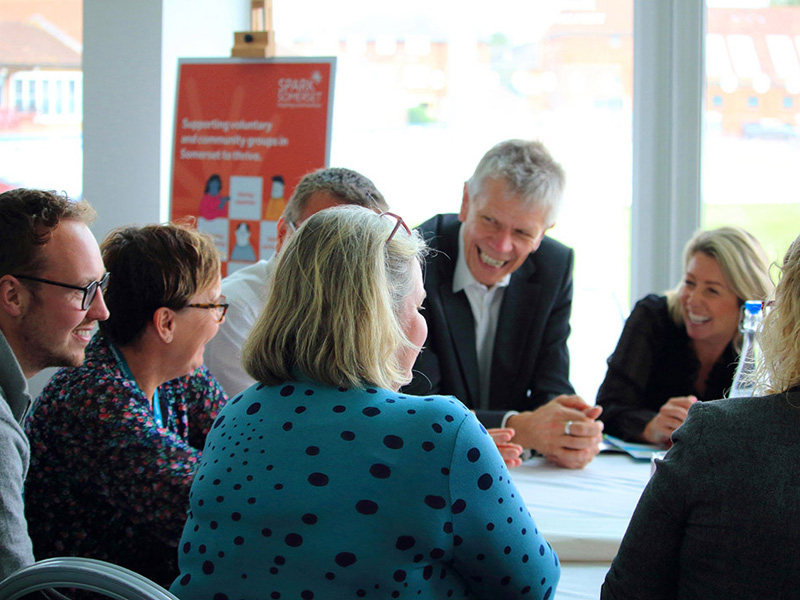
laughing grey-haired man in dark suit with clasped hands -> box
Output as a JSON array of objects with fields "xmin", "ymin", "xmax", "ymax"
[{"xmin": 406, "ymin": 140, "xmax": 603, "ymax": 468}]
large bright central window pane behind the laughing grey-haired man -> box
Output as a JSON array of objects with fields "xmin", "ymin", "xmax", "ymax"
[{"xmin": 274, "ymin": 0, "xmax": 633, "ymax": 399}]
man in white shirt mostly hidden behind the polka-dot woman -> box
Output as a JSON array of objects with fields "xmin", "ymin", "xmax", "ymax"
[{"xmin": 205, "ymin": 168, "xmax": 388, "ymax": 398}]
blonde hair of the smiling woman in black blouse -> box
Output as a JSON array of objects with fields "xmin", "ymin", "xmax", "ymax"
[{"xmin": 667, "ymin": 227, "xmax": 773, "ymax": 332}]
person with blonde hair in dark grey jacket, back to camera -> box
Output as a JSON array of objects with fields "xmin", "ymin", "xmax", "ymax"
[{"xmin": 601, "ymin": 231, "xmax": 800, "ymax": 600}]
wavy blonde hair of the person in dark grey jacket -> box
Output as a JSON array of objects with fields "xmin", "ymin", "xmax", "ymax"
[{"xmin": 758, "ymin": 236, "xmax": 800, "ymax": 393}]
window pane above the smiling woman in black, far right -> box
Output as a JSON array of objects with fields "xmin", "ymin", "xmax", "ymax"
[{"xmin": 703, "ymin": 0, "xmax": 800, "ymax": 270}]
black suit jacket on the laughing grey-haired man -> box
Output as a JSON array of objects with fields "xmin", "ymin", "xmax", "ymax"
[{"xmin": 404, "ymin": 214, "xmax": 574, "ymax": 427}]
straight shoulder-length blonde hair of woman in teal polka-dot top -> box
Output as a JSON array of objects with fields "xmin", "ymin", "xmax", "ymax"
[{"xmin": 242, "ymin": 206, "xmax": 425, "ymax": 389}]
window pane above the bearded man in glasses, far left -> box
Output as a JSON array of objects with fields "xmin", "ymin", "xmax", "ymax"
[{"xmin": 0, "ymin": 0, "xmax": 83, "ymax": 197}]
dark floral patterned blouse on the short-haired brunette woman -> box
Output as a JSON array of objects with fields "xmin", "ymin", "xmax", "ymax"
[{"xmin": 25, "ymin": 333, "xmax": 227, "ymax": 585}]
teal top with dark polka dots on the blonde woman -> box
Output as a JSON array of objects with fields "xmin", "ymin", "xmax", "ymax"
[{"xmin": 171, "ymin": 379, "xmax": 560, "ymax": 600}]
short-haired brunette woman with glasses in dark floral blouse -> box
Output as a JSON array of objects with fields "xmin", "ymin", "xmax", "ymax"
[{"xmin": 25, "ymin": 225, "xmax": 227, "ymax": 585}]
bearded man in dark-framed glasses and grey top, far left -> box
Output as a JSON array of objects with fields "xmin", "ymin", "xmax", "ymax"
[{"xmin": 0, "ymin": 189, "xmax": 108, "ymax": 580}]
